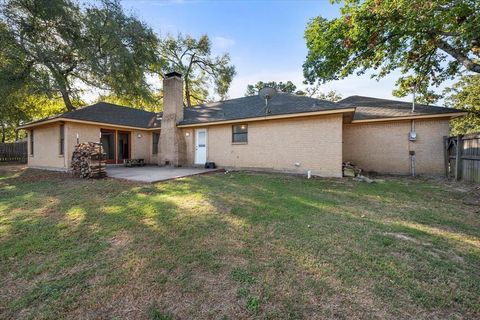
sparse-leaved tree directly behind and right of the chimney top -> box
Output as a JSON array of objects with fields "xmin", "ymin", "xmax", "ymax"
[{"xmin": 159, "ymin": 34, "xmax": 236, "ymax": 107}]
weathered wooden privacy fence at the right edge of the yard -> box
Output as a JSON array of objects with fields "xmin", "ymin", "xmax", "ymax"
[{"xmin": 444, "ymin": 133, "xmax": 480, "ymax": 182}]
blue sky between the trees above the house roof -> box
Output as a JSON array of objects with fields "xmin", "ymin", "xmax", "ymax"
[{"xmin": 122, "ymin": 0, "xmax": 450, "ymax": 101}]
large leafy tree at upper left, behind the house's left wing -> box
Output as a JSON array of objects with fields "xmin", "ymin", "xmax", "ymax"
[{"xmin": 0, "ymin": 0, "xmax": 161, "ymax": 110}]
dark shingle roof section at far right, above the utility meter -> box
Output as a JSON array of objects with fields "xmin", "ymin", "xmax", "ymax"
[{"xmin": 337, "ymin": 96, "xmax": 460, "ymax": 120}]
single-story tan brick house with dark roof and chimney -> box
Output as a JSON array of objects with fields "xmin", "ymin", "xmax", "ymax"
[{"xmin": 21, "ymin": 73, "xmax": 465, "ymax": 177}]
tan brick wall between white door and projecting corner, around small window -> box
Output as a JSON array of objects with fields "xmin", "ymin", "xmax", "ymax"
[{"xmin": 202, "ymin": 115, "xmax": 342, "ymax": 177}]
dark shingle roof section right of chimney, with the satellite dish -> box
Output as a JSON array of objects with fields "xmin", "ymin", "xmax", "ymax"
[{"xmin": 181, "ymin": 93, "xmax": 348, "ymax": 124}]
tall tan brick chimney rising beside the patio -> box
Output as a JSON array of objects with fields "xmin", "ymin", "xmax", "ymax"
[{"xmin": 158, "ymin": 72, "xmax": 186, "ymax": 167}]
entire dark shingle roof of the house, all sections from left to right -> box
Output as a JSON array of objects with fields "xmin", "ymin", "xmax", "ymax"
[{"xmin": 20, "ymin": 93, "xmax": 461, "ymax": 128}]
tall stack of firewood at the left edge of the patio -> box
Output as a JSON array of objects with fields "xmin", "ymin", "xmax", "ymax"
[{"xmin": 72, "ymin": 142, "xmax": 107, "ymax": 179}]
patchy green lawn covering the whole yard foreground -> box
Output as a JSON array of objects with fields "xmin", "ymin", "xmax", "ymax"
[{"xmin": 0, "ymin": 167, "xmax": 480, "ymax": 319}]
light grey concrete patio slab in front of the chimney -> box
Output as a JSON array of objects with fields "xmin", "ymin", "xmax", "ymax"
[{"xmin": 107, "ymin": 165, "xmax": 217, "ymax": 183}]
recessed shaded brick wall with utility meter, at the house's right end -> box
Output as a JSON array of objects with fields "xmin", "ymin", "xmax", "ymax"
[{"xmin": 343, "ymin": 119, "xmax": 449, "ymax": 175}]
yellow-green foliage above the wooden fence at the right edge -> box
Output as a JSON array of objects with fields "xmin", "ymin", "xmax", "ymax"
[{"xmin": 445, "ymin": 74, "xmax": 480, "ymax": 135}]
